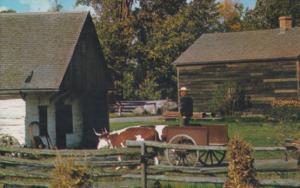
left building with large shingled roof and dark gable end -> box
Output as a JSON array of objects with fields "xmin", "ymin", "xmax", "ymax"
[{"xmin": 0, "ymin": 12, "xmax": 109, "ymax": 148}]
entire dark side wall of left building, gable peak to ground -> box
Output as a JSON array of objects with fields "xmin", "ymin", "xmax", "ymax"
[{"xmin": 61, "ymin": 13, "xmax": 109, "ymax": 148}]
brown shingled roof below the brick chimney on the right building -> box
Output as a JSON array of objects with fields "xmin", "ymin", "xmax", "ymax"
[{"xmin": 174, "ymin": 28, "xmax": 300, "ymax": 66}]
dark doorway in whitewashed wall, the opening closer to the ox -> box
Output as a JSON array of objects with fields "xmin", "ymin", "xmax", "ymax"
[{"xmin": 55, "ymin": 104, "xmax": 73, "ymax": 149}]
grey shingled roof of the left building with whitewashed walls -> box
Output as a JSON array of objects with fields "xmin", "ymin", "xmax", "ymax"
[{"xmin": 0, "ymin": 12, "xmax": 89, "ymax": 93}]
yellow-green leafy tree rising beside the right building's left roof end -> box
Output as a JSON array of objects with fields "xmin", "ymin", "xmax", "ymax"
[{"xmin": 135, "ymin": 0, "xmax": 218, "ymax": 99}]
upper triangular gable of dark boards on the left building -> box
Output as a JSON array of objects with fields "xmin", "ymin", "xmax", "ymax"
[{"xmin": 61, "ymin": 16, "xmax": 108, "ymax": 92}]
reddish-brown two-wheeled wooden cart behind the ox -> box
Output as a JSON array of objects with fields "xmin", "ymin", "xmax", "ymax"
[{"xmin": 163, "ymin": 125, "xmax": 228, "ymax": 166}]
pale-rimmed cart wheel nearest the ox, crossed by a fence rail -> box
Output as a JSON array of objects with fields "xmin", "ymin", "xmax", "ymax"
[{"xmin": 165, "ymin": 134, "xmax": 199, "ymax": 166}]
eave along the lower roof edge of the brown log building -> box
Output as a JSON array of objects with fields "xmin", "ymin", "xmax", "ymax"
[{"xmin": 173, "ymin": 56, "xmax": 300, "ymax": 67}]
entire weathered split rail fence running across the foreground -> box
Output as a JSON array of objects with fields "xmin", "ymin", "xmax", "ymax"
[{"xmin": 0, "ymin": 141, "xmax": 300, "ymax": 187}]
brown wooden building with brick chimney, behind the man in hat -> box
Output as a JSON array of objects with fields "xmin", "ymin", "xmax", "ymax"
[{"xmin": 174, "ymin": 17, "xmax": 300, "ymax": 111}]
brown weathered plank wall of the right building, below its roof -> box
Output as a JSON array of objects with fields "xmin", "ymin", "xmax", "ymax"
[{"xmin": 177, "ymin": 61, "xmax": 299, "ymax": 111}]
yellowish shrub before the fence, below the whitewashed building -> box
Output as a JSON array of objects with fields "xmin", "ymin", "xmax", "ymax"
[{"xmin": 50, "ymin": 157, "xmax": 92, "ymax": 188}]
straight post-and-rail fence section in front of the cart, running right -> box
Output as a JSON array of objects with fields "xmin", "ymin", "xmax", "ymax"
[{"xmin": 123, "ymin": 141, "xmax": 300, "ymax": 188}]
